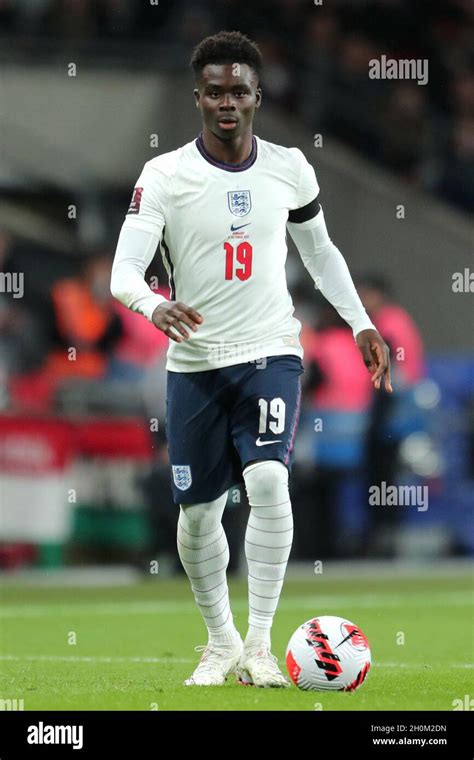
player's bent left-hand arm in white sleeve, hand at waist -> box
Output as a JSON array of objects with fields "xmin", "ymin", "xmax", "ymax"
[{"xmin": 110, "ymin": 164, "xmax": 203, "ymax": 343}]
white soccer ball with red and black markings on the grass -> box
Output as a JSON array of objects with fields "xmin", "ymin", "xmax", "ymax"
[{"xmin": 286, "ymin": 615, "xmax": 371, "ymax": 691}]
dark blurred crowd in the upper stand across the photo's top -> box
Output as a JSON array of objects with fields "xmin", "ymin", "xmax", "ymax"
[{"xmin": 0, "ymin": 0, "xmax": 474, "ymax": 211}]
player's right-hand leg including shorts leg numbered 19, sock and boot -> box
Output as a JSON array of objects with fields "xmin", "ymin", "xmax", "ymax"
[{"xmin": 227, "ymin": 356, "xmax": 303, "ymax": 686}]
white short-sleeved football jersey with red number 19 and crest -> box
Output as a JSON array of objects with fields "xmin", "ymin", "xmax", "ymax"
[{"xmin": 120, "ymin": 136, "xmax": 319, "ymax": 372}]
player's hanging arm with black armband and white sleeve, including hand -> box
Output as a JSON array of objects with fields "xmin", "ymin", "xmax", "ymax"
[{"xmin": 287, "ymin": 198, "xmax": 392, "ymax": 392}]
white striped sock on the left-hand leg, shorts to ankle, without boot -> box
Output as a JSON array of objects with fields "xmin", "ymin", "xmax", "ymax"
[{"xmin": 178, "ymin": 491, "xmax": 239, "ymax": 644}]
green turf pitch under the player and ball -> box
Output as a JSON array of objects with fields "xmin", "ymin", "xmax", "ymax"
[{"xmin": 0, "ymin": 573, "xmax": 473, "ymax": 710}]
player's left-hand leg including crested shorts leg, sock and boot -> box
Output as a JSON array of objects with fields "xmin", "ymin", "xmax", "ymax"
[{"xmin": 166, "ymin": 371, "xmax": 242, "ymax": 685}]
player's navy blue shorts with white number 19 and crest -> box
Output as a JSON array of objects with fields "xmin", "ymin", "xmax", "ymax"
[{"xmin": 166, "ymin": 355, "xmax": 304, "ymax": 504}]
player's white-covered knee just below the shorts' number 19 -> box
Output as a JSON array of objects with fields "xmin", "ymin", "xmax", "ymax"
[{"xmin": 243, "ymin": 459, "xmax": 289, "ymax": 507}]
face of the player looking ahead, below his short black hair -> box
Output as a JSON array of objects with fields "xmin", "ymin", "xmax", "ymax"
[{"xmin": 194, "ymin": 63, "xmax": 262, "ymax": 140}]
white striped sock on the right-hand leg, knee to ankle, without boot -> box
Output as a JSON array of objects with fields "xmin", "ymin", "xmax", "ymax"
[{"xmin": 243, "ymin": 460, "xmax": 293, "ymax": 648}]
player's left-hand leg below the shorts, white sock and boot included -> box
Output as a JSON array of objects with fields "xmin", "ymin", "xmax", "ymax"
[{"xmin": 178, "ymin": 491, "xmax": 242, "ymax": 686}]
